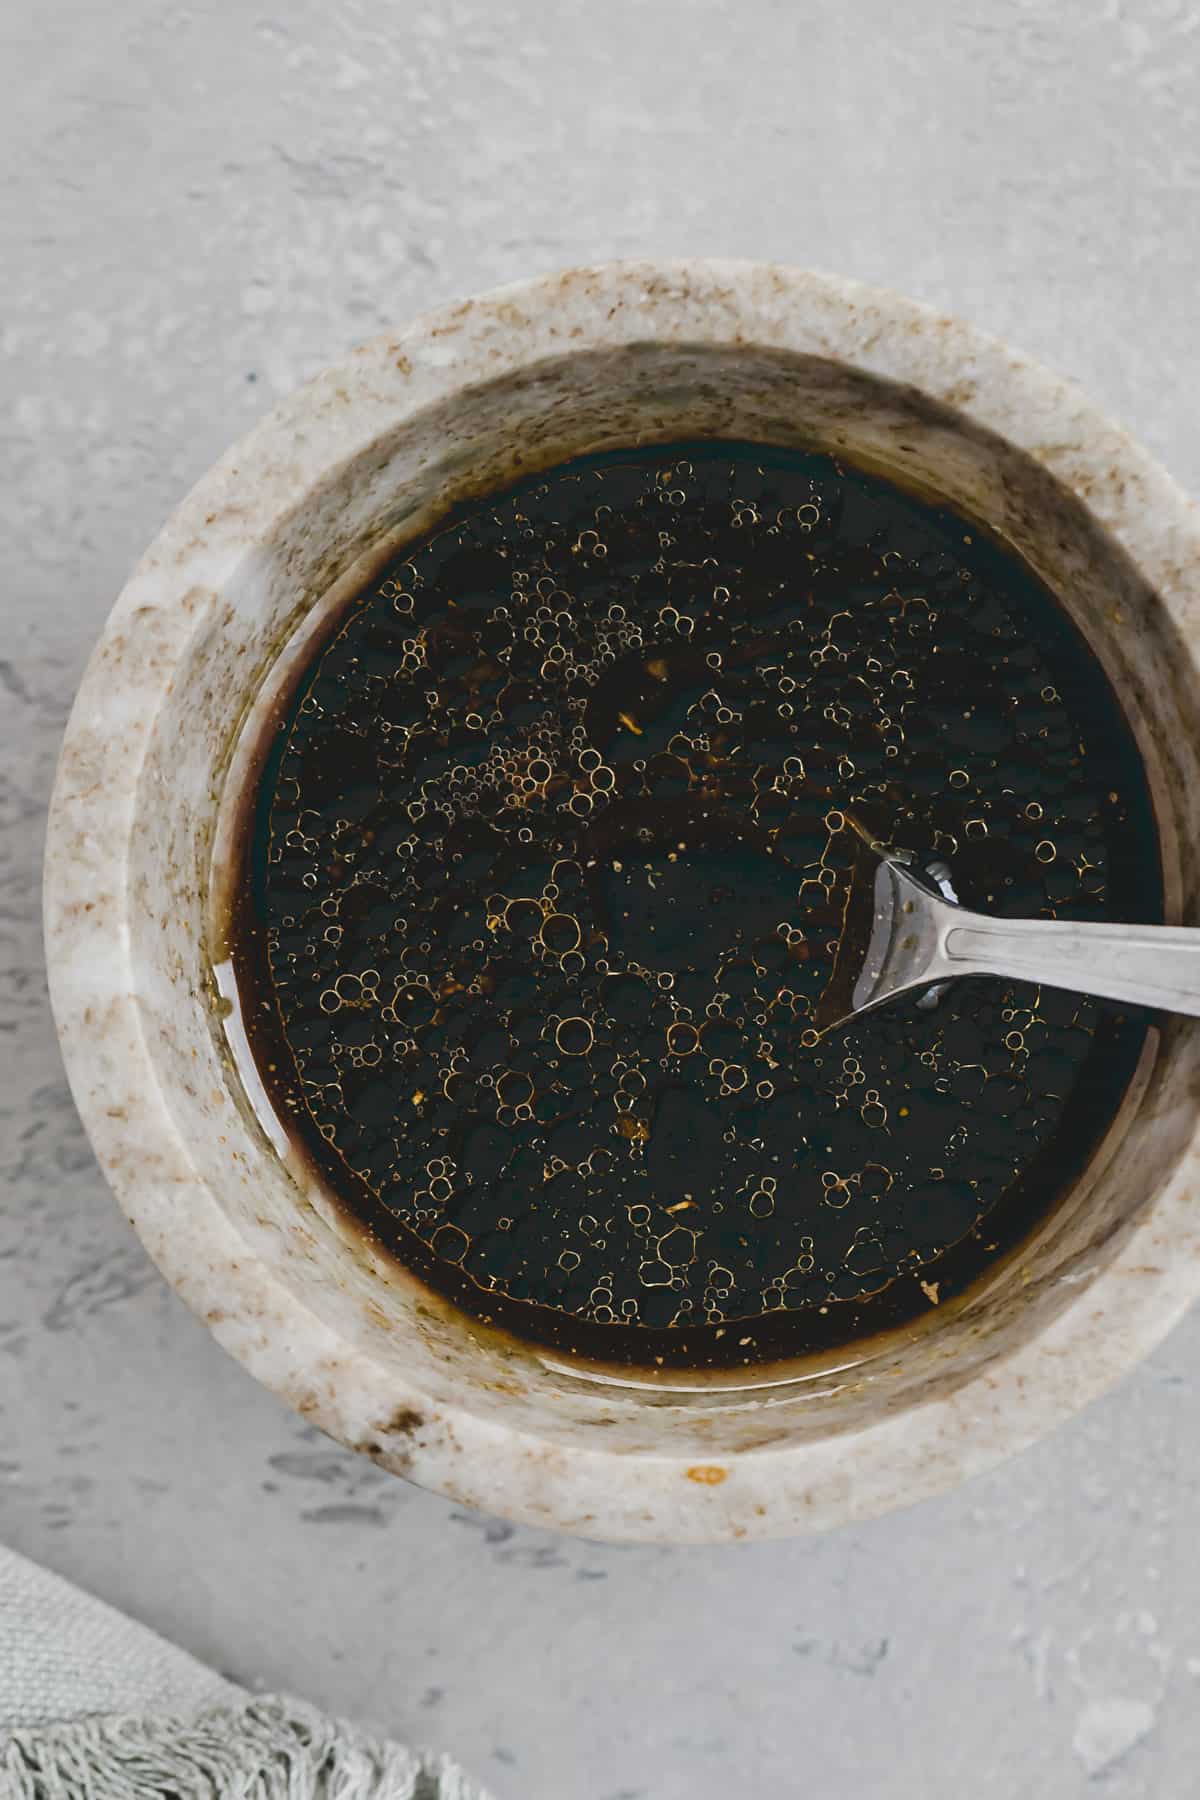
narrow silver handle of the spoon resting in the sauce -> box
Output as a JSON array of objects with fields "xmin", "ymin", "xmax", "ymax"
[{"xmin": 939, "ymin": 909, "xmax": 1200, "ymax": 1017}]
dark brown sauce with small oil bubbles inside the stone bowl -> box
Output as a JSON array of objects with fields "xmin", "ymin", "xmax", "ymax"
[{"xmin": 224, "ymin": 443, "xmax": 1162, "ymax": 1368}]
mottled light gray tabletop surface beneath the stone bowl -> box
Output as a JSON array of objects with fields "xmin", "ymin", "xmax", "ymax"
[{"xmin": 0, "ymin": 0, "xmax": 1200, "ymax": 1800}]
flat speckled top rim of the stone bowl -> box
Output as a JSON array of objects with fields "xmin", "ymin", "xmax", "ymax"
[{"xmin": 45, "ymin": 259, "xmax": 1200, "ymax": 1543}]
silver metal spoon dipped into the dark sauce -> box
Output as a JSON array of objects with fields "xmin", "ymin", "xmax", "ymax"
[{"xmin": 813, "ymin": 821, "xmax": 1200, "ymax": 1031}]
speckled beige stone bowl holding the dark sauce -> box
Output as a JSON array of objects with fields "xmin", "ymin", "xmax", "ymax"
[{"xmin": 47, "ymin": 263, "xmax": 1200, "ymax": 1541}]
